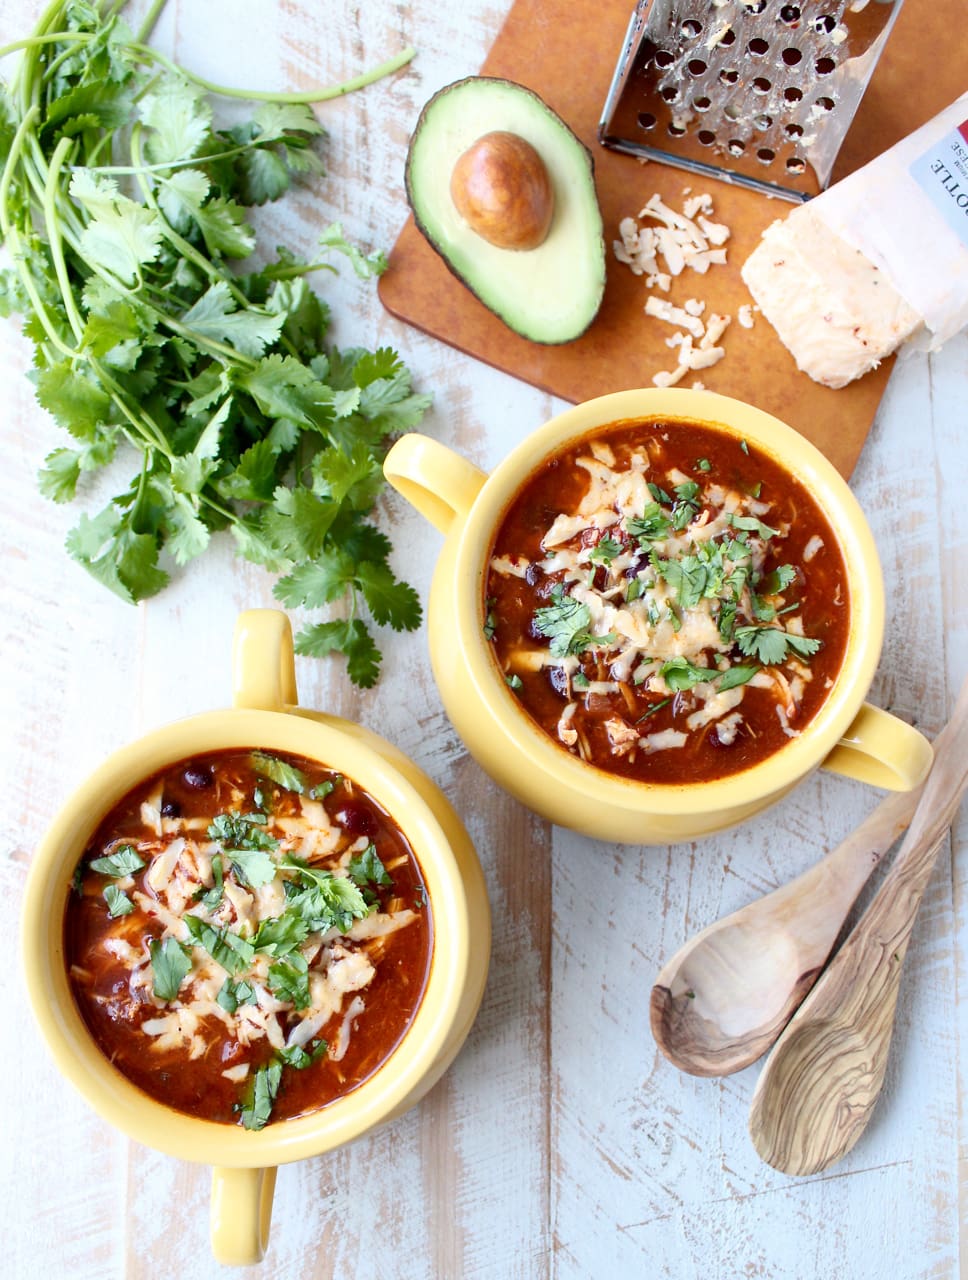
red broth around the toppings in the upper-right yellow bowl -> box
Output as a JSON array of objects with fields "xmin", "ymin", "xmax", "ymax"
[{"xmin": 483, "ymin": 419, "xmax": 850, "ymax": 785}]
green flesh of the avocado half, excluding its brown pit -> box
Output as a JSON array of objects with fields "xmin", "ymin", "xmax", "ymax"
[{"xmin": 406, "ymin": 76, "xmax": 606, "ymax": 344}]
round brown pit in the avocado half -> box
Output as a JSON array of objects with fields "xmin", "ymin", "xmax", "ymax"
[{"xmin": 451, "ymin": 129, "xmax": 554, "ymax": 250}]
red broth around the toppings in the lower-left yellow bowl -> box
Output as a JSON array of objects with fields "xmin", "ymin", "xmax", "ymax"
[{"xmin": 64, "ymin": 750, "xmax": 433, "ymax": 1124}]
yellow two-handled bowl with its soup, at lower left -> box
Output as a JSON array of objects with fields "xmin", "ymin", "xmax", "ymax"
[{"xmin": 23, "ymin": 609, "xmax": 490, "ymax": 1265}]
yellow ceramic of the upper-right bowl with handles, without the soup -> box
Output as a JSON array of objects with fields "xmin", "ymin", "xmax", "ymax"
[{"xmin": 384, "ymin": 388, "xmax": 931, "ymax": 844}]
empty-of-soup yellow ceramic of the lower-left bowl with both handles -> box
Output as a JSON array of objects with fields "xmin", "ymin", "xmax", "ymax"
[{"xmin": 23, "ymin": 609, "xmax": 490, "ymax": 1265}]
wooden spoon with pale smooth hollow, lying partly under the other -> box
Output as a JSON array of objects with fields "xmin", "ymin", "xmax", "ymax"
[{"xmin": 649, "ymin": 768, "xmax": 940, "ymax": 1075}]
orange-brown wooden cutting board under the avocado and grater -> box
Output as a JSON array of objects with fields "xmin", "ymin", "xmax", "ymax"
[{"xmin": 380, "ymin": 0, "xmax": 968, "ymax": 476}]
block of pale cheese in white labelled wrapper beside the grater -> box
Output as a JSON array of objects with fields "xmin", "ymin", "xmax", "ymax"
[{"xmin": 741, "ymin": 95, "xmax": 968, "ymax": 387}]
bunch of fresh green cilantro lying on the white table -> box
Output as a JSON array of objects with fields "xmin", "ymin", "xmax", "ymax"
[{"xmin": 0, "ymin": 0, "xmax": 429, "ymax": 686}]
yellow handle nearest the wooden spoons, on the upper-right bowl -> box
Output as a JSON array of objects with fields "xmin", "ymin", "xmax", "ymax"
[{"xmin": 823, "ymin": 703, "xmax": 933, "ymax": 791}]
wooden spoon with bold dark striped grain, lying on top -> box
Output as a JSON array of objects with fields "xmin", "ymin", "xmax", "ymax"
[{"xmin": 749, "ymin": 681, "xmax": 968, "ymax": 1175}]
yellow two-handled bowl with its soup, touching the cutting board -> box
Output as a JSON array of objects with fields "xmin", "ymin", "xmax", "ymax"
[{"xmin": 385, "ymin": 388, "xmax": 931, "ymax": 844}]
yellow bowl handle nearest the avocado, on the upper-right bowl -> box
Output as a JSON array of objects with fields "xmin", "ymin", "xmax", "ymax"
[{"xmin": 383, "ymin": 431, "xmax": 488, "ymax": 534}]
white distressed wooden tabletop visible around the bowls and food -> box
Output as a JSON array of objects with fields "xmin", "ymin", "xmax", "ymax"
[{"xmin": 0, "ymin": 0, "xmax": 968, "ymax": 1280}]
